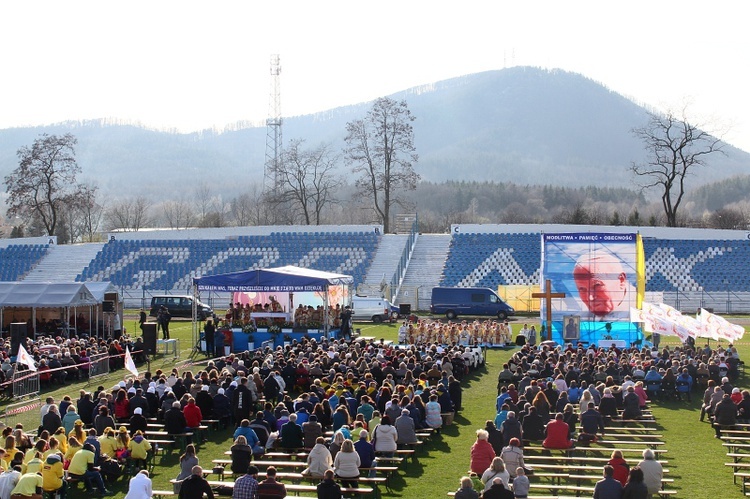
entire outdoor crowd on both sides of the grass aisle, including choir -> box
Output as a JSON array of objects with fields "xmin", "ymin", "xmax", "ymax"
[{"xmin": 0, "ymin": 321, "xmax": 750, "ymax": 499}]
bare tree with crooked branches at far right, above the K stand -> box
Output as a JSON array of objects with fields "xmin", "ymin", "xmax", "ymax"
[{"xmin": 630, "ymin": 108, "xmax": 723, "ymax": 227}]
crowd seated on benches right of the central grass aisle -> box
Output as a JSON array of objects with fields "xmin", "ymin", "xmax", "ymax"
[{"xmin": 456, "ymin": 343, "xmax": 750, "ymax": 499}]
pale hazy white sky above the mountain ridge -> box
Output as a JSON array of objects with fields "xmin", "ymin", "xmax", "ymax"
[{"xmin": 0, "ymin": 0, "xmax": 750, "ymax": 151}]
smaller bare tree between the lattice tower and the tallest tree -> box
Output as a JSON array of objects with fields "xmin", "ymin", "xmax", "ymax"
[{"xmin": 272, "ymin": 139, "xmax": 341, "ymax": 225}]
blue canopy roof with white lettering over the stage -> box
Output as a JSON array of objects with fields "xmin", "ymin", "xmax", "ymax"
[{"xmin": 193, "ymin": 265, "xmax": 353, "ymax": 293}]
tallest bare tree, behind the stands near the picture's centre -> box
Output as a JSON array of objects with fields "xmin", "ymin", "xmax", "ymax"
[{"xmin": 345, "ymin": 97, "xmax": 419, "ymax": 232}]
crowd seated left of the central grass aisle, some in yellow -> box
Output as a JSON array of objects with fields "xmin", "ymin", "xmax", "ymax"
[{"xmin": 0, "ymin": 332, "xmax": 488, "ymax": 499}]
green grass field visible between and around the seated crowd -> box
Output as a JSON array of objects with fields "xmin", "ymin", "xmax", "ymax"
[{"xmin": 0, "ymin": 320, "xmax": 750, "ymax": 499}]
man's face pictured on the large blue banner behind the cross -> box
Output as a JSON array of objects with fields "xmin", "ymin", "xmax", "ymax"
[{"xmin": 573, "ymin": 256, "xmax": 628, "ymax": 316}]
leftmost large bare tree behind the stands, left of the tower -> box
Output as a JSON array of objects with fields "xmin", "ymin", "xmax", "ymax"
[{"xmin": 5, "ymin": 133, "xmax": 87, "ymax": 235}]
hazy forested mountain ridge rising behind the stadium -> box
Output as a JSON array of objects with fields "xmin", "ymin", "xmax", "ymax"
[{"xmin": 0, "ymin": 67, "xmax": 750, "ymax": 199}]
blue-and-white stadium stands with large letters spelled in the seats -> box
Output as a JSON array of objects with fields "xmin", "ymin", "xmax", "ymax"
[{"xmin": 0, "ymin": 223, "xmax": 750, "ymax": 313}]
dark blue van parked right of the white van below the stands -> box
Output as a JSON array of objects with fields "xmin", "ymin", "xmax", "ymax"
[{"xmin": 430, "ymin": 288, "xmax": 516, "ymax": 320}]
